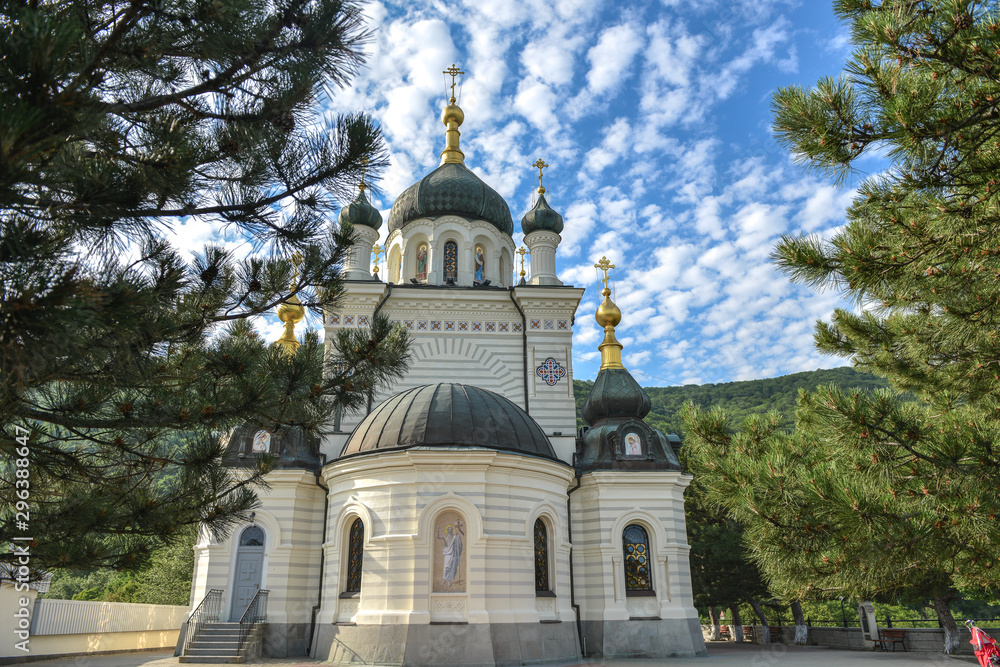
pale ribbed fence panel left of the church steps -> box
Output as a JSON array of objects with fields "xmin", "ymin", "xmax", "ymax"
[{"xmin": 31, "ymin": 600, "xmax": 189, "ymax": 636}]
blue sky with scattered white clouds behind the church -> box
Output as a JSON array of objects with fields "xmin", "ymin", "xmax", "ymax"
[{"xmin": 168, "ymin": 0, "xmax": 853, "ymax": 386}]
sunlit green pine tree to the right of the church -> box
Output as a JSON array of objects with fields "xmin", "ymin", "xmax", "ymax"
[{"xmin": 688, "ymin": 0, "xmax": 1000, "ymax": 651}]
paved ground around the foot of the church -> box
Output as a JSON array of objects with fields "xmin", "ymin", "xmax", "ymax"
[{"xmin": 19, "ymin": 642, "xmax": 978, "ymax": 667}]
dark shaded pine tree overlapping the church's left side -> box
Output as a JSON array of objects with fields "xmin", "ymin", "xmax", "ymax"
[{"xmin": 0, "ymin": 0, "xmax": 407, "ymax": 570}]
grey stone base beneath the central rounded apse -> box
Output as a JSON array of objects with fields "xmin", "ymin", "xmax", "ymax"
[{"xmin": 312, "ymin": 622, "xmax": 580, "ymax": 667}]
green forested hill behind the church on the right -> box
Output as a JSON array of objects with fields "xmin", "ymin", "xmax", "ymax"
[{"xmin": 573, "ymin": 367, "xmax": 888, "ymax": 438}]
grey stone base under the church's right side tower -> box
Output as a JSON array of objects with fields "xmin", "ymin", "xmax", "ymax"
[{"xmin": 583, "ymin": 618, "xmax": 708, "ymax": 660}]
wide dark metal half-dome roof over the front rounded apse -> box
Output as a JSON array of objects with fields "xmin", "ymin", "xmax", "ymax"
[{"xmin": 340, "ymin": 383, "xmax": 556, "ymax": 459}]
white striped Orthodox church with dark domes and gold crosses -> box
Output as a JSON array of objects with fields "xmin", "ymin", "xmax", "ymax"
[{"xmin": 186, "ymin": 70, "xmax": 705, "ymax": 665}]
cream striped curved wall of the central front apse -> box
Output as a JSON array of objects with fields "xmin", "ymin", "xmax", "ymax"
[{"xmin": 317, "ymin": 448, "xmax": 574, "ymax": 625}]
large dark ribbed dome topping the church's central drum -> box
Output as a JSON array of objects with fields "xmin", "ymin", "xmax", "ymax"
[{"xmin": 389, "ymin": 162, "xmax": 514, "ymax": 236}]
